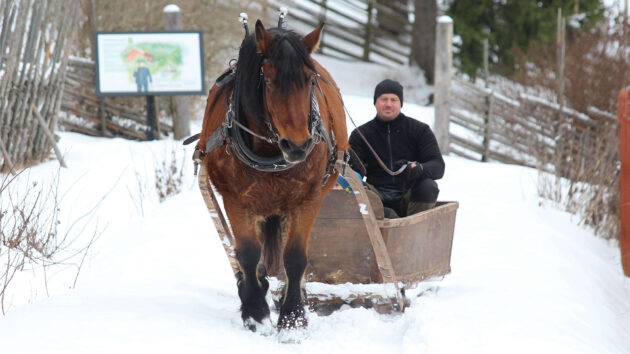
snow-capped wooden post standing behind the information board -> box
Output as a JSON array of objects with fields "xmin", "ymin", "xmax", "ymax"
[{"xmin": 164, "ymin": 4, "xmax": 191, "ymax": 140}]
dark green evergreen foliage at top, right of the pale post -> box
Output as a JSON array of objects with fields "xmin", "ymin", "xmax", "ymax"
[{"xmin": 447, "ymin": 0, "xmax": 604, "ymax": 78}]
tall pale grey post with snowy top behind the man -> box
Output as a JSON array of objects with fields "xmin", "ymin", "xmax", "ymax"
[{"xmin": 433, "ymin": 16, "xmax": 453, "ymax": 155}]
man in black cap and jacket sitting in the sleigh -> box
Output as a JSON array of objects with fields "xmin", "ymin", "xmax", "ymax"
[{"xmin": 350, "ymin": 79, "xmax": 444, "ymax": 218}]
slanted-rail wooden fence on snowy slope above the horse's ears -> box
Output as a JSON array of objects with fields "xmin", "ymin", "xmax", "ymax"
[{"xmin": 287, "ymin": 0, "xmax": 412, "ymax": 64}]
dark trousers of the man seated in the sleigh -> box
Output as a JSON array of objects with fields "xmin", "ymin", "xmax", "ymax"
[{"xmin": 368, "ymin": 178, "xmax": 440, "ymax": 216}]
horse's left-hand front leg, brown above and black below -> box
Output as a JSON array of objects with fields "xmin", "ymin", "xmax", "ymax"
[{"xmin": 225, "ymin": 202, "xmax": 269, "ymax": 331}]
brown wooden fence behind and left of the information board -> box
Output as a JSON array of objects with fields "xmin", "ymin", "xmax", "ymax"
[{"xmin": 59, "ymin": 59, "xmax": 173, "ymax": 140}]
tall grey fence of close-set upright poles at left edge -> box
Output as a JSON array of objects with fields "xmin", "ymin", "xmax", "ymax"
[{"xmin": 0, "ymin": 0, "xmax": 80, "ymax": 172}]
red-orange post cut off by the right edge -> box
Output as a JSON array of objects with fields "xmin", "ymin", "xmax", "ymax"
[{"xmin": 617, "ymin": 88, "xmax": 630, "ymax": 277}]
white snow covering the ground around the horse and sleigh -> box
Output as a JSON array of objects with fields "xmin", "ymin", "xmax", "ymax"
[{"xmin": 0, "ymin": 57, "xmax": 630, "ymax": 354}]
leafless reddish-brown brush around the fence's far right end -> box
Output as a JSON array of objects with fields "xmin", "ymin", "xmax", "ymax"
[{"xmin": 514, "ymin": 22, "xmax": 630, "ymax": 238}]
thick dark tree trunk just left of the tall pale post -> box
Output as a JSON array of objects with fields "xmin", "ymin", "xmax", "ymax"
[{"xmin": 411, "ymin": 0, "xmax": 437, "ymax": 85}]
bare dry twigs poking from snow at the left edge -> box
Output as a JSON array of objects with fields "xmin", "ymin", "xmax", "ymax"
[{"xmin": 0, "ymin": 170, "xmax": 100, "ymax": 314}]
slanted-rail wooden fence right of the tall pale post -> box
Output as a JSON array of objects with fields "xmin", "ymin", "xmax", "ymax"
[{"xmin": 449, "ymin": 77, "xmax": 617, "ymax": 180}]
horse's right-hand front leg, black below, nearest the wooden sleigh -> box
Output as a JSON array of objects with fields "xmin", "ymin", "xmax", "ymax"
[{"xmin": 278, "ymin": 203, "xmax": 319, "ymax": 329}]
